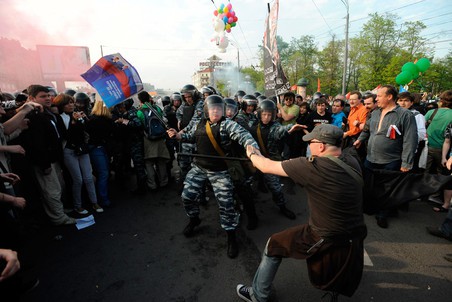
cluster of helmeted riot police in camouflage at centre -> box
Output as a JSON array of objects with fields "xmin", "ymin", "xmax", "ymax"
[{"xmin": 164, "ymin": 84, "xmax": 296, "ymax": 258}]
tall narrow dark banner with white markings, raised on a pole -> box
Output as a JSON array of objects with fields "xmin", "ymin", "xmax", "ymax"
[{"xmin": 264, "ymin": 0, "xmax": 290, "ymax": 97}]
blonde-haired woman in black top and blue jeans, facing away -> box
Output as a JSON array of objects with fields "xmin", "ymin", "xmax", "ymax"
[{"xmin": 86, "ymin": 94, "xmax": 113, "ymax": 207}]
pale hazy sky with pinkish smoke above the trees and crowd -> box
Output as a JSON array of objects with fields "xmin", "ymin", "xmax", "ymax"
[{"xmin": 0, "ymin": 0, "xmax": 452, "ymax": 90}]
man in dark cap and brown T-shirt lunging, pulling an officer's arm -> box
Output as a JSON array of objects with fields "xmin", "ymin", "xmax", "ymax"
[{"xmin": 237, "ymin": 124, "xmax": 367, "ymax": 302}]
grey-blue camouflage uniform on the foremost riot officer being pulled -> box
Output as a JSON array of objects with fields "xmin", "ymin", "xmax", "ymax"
[{"xmin": 181, "ymin": 118, "xmax": 258, "ymax": 231}]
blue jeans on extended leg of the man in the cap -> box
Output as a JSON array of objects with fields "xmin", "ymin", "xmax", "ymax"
[{"xmin": 250, "ymin": 242, "xmax": 282, "ymax": 302}]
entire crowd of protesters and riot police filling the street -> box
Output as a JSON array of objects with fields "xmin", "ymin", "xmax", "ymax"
[{"xmin": 0, "ymin": 84, "xmax": 452, "ymax": 301}]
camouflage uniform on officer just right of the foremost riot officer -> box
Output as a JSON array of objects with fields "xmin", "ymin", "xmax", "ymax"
[{"xmin": 251, "ymin": 122, "xmax": 292, "ymax": 206}]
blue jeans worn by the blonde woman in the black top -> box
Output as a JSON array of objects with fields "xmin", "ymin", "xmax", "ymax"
[{"xmin": 89, "ymin": 146, "xmax": 110, "ymax": 206}]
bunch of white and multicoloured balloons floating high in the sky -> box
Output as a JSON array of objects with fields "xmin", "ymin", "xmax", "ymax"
[{"xmin": 212, "ymin": 3, "xmax": 239, "ymax": 52}]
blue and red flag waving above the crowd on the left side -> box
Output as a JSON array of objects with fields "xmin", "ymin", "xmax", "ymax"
[{"xmin": 81, "ymin": 53, "xmax": 143, "ymax": 107}]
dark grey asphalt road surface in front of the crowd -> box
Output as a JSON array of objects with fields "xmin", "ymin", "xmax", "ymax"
[{"xmin": 22, "ymin": 175, "xmax": 452, "ymax": 302}]
